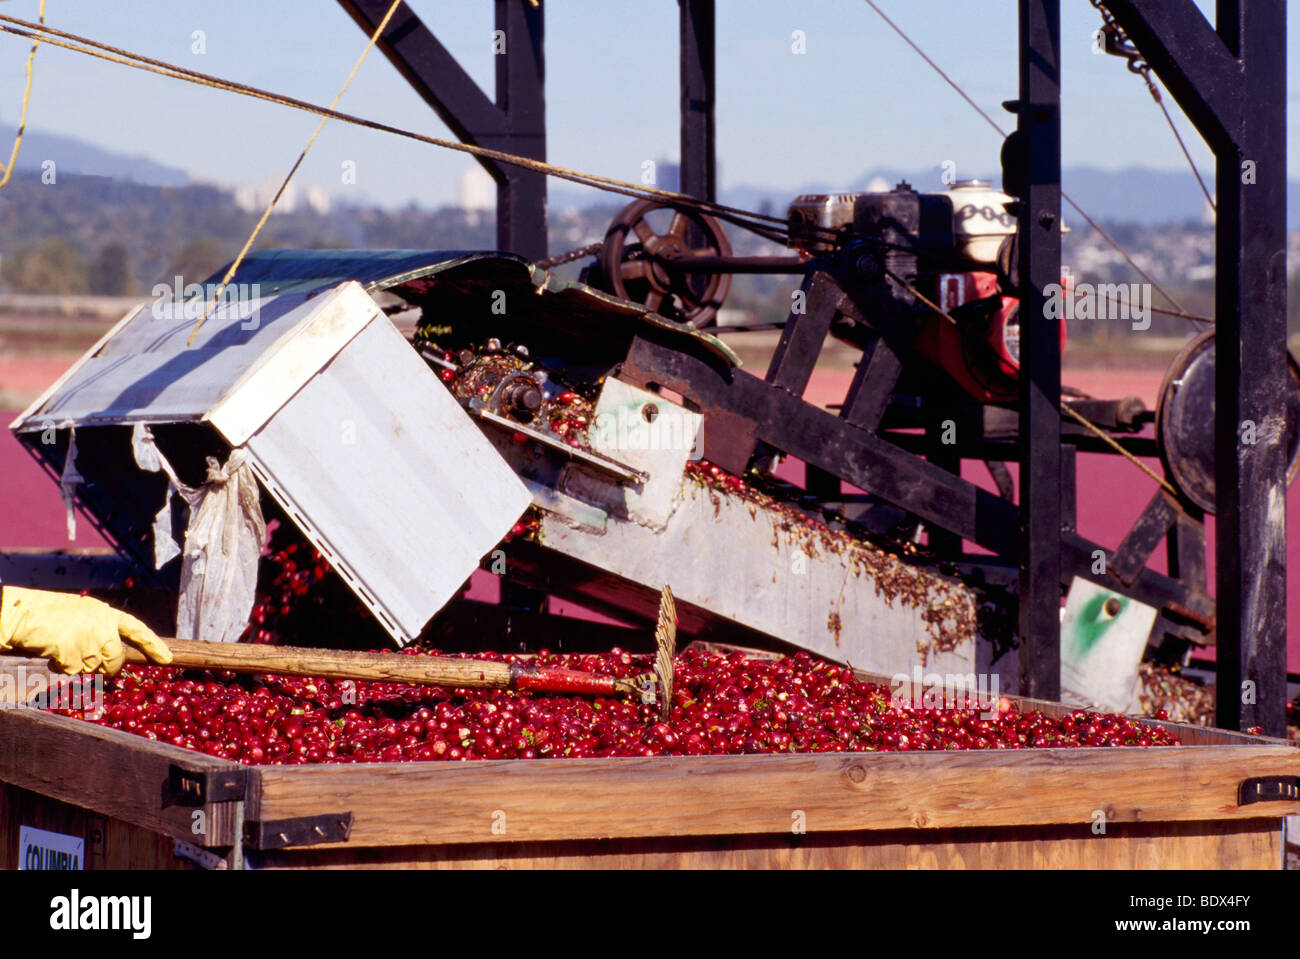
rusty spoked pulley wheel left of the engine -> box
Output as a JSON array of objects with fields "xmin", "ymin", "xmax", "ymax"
[{"xmin": 601, "ymin": 200, "xmax": 732, "ymax": 329}]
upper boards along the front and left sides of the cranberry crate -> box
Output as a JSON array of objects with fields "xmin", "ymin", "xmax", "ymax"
[{"xmin": 0, "ymin": 654, "xmax": 1284, "ymax": 849}]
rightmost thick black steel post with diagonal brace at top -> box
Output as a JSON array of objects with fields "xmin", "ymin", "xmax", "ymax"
[{"xmin": 1108, "ymin": 0, "xmax": 1287, "ymax": 735}]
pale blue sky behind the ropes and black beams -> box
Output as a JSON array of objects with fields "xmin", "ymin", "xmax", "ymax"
[{"xmin": 0, "ymin": 0, "xmax": 1300, "ymax": 205}]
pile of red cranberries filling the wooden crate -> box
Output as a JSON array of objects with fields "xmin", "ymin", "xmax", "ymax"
[{"xmin": 50, "ymin": 641, "xmax": 1178, "ymax": 764}]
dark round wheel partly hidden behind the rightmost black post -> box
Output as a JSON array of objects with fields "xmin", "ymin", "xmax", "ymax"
[{"xmin": 1156, "ymin": 330, "xmax": 1300, "ymax": 513}]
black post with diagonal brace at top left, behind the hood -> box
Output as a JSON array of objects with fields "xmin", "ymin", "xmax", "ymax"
[{"xmin": 338, "ymin": 0, "xmax": 546, "ymax": 260}]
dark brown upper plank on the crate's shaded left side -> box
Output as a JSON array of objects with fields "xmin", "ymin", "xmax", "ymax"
[{"xmin": 0, "ymin": 708, "xmax": 241, "ymax": 846}]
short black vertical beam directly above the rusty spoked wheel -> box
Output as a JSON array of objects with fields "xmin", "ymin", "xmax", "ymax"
[{"xmin": 677, "ymin": 0, "xmax": 718, "ymax": 200}]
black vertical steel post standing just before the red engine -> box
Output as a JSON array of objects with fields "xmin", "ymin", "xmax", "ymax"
[{"xmin": 1017, "ymin": 0, "xmax": 1061, "ymax": 700}]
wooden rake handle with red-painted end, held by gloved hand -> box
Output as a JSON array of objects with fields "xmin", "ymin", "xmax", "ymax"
[{"xmin": 126, "ymin": 637, "xmax": 637, "ymax": 695}]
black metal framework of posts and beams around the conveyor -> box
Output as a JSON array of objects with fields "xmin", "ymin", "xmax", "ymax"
[{"xmin": 339, "ymin": 0, "xmax": 1287, "ymax": 734}]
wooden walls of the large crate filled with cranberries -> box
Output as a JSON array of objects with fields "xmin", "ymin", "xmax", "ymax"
[{"xmin": 0, "ymin": 649, "xmax": 1300, "ymax": 868}]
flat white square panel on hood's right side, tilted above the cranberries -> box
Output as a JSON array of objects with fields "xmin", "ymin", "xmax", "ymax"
[{"xmin": 247, "ymin": 317, "xmax": 532, "ymax": 643}]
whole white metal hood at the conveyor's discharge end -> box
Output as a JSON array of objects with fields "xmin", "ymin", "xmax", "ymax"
[{"xmin": 13, "ymin": 282, "xmax": 532, "ymax": 642}]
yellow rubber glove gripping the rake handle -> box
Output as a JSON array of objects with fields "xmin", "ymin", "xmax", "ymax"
[{"xmin": 0, "ymin": 586, "xmax": 172, "ymax": 676}]
